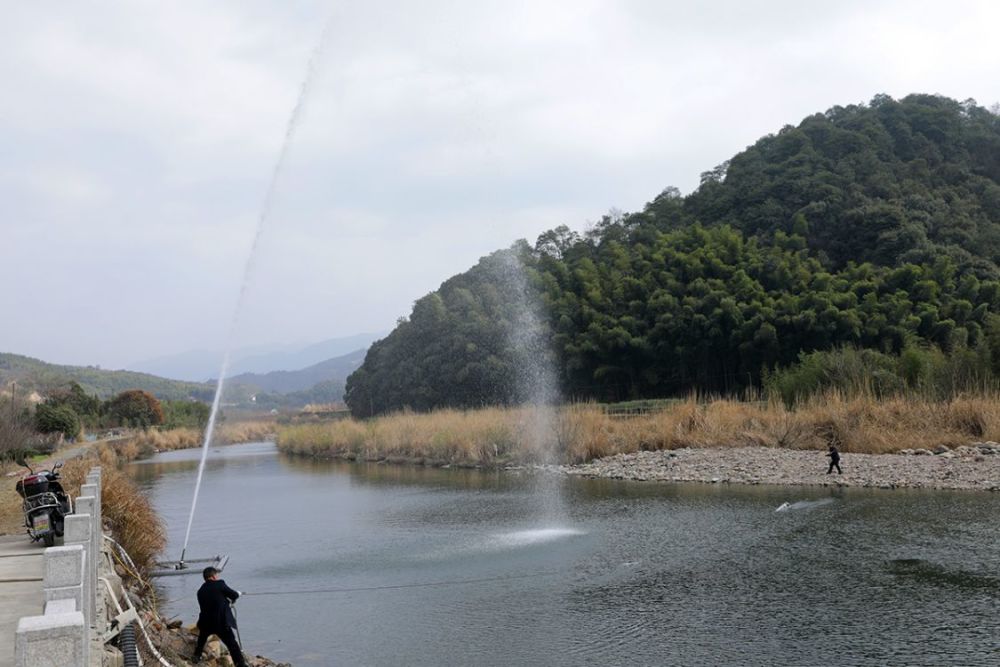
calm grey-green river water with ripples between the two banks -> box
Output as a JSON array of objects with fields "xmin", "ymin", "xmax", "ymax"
[{"xmin": 132, "ymin": 443, "xmax": 1000, "ymax": 666}]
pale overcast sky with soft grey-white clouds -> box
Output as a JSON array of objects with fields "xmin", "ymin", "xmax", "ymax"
[{"xmin": 0, "ymin": 0, "xmax": 1000, "ymax": 368}]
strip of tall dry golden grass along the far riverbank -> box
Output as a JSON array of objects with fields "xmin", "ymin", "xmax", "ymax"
[{"xmin": 277, "ymin": 393, "xmax": 1000, "ymax": 465}]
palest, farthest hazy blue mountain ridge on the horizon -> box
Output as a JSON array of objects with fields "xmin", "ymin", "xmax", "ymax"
[{"xmin": 128, "ymin": 332, "xmax": 385, "ymax": 382}]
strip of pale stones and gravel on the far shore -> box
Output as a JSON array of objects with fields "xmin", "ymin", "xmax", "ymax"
[{"xmin": 562, "ymin": 442, "xmax": 1000, "ymax": 491}]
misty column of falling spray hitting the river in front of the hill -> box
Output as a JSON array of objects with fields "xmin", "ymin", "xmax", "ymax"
[{"xmin": 495, "ymin": 246, "xmax": 566, "ymax": 523}]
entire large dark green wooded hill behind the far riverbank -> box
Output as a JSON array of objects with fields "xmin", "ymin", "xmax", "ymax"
[{"xmin": 346, "ymin": 95, "xmax": 1000, "ymax": 415}]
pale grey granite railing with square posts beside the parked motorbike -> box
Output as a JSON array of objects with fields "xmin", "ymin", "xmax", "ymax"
[{"xmin": 14, "ymin": 468, "xmax": 106, "ymax": 667}]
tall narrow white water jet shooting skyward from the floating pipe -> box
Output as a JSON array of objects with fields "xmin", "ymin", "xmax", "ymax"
[{"xmin": 180, "ymin": 22, "xmax": 333, "ymax": 563}]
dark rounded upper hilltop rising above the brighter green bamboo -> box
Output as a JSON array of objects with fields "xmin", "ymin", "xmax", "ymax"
[{"xmin": 684, "ymin": 95, "xmax": 1000, "ymax": 278}]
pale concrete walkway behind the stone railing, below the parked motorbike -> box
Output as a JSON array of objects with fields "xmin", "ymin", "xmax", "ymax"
[{"xmin": 0, "ymin": 535, "xmax": 45, "ymax": 667}]
